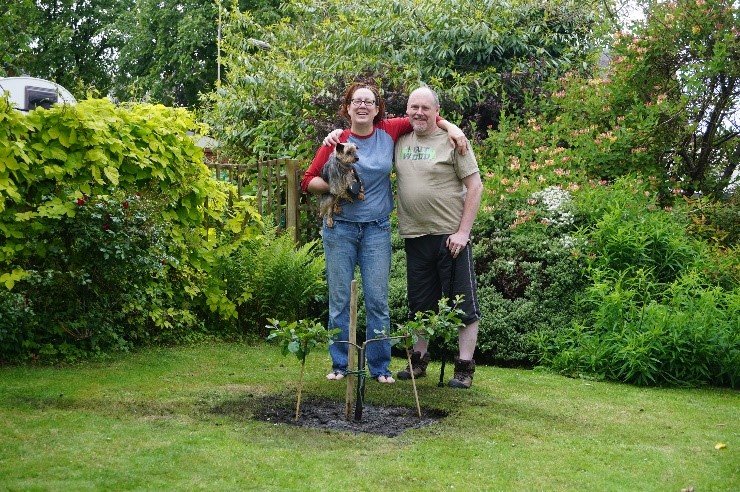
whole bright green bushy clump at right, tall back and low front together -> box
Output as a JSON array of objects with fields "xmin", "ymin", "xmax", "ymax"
[{"xmin": 533, "ymin": 179, "xmax": 740, "ymax": 387}]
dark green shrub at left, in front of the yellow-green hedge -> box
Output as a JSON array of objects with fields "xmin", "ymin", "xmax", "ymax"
[{"xmin": 4, "ymin": 192, "xmax": 207, "ymax": 359}]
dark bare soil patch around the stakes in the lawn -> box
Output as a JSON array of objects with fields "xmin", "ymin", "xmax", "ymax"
[{"xmin": 211, "ymin": 395, "xmax": 447, "ymax": 437}]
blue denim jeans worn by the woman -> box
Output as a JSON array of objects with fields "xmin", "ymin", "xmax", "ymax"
[{"xmin": 322, "ymin": 217, "xmax": 391, "ymax": 378}]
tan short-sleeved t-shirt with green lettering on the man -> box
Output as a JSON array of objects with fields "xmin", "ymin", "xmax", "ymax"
[{"xmin": 395, "ymin": 129, "xmax": 478, "ymax": 238}]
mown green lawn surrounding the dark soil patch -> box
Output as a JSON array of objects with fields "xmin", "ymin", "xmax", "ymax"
[{"xmin": 0, "ymin": 344, "xmax": 740, "ymax": 491}]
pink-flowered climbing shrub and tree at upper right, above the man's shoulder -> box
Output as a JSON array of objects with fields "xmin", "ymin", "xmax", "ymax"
[{"xmin": 478, "ymin": 0, "xmax": 740, "ymax": 197}]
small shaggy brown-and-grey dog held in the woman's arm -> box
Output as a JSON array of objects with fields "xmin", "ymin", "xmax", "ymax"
[{"xmin": 319, "ymin": 142, "xmax": 365, "ymax": 227}]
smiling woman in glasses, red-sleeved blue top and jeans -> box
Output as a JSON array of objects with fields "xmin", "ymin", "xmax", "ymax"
[{"xmin": 301, "ymin": 83, "xmax": 465, "ymax": 383}]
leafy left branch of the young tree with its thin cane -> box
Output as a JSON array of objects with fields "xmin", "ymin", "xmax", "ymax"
[{"xmin": 266, "ymin": 319, "xmax": 339, "ymax": 420}]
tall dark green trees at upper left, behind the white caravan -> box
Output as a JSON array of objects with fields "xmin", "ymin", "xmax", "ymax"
[{"xmin": 0, "ymin": 0, "xmax": 280, "ymax": 108}]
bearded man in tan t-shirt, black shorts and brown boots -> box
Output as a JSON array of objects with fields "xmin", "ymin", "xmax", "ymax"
[{"xmin": 395, "ymin": 87, "xmax": 483, "ymax": 389}]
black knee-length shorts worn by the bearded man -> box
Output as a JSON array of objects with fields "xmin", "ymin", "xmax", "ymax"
[{"xmin": 404, "ymin": 235, "xmax": 480, "ymax": 325}]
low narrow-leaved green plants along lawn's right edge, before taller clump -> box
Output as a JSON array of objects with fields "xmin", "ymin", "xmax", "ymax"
[{"xmin": 540, "ymin": 272, "xmax": 740, "ymax": 388}]
